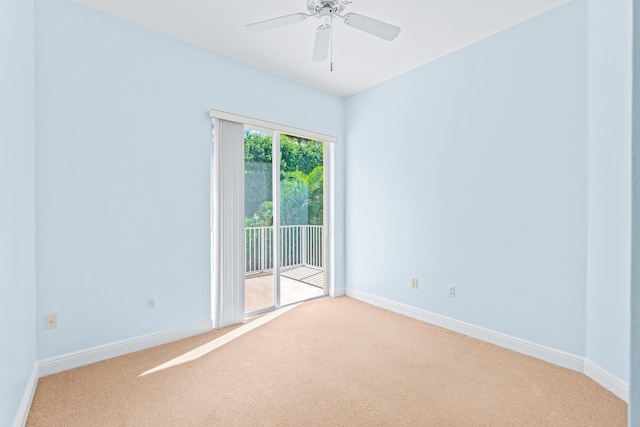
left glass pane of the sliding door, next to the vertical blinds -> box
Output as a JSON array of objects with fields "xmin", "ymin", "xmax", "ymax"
[{"xmin": 244, "ymin": 129, "xmax": 275, "ymax": 313}]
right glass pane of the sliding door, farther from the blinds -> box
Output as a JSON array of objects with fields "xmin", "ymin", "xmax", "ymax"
[{"xmin": 280, "ymin": 135, "xmax": 325, "ymax": 305}]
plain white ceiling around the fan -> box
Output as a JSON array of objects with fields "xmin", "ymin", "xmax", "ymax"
[{"xmin": 75, "ymin": 0, "xmax": 570, "ymax": 97}]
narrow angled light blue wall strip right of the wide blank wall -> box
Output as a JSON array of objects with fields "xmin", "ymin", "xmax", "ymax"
[{"xmin": 585, "ymin": 0, "xmax": 632, "ymax": 381}]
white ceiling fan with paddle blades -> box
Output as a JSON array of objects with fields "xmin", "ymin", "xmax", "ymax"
[{"xmin": 245, "ymin": 0, "xmax": 400, "ymax": 62}]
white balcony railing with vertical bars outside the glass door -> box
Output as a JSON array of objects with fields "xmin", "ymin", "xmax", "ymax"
[{"xmin": 245, "ymin": 225, "xmax": 323, "ymax": 273}]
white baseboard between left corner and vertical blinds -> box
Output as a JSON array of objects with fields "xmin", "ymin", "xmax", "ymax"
[{"xmin": 38, "ymin": 320, "xmax": 213, "ymax": 377}]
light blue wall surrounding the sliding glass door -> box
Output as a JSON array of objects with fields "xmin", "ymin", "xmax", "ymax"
[{"xmin": 35, "ymin": 0, "xmax": 344, "ymax": 359}]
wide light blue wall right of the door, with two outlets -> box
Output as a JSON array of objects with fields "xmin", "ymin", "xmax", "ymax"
[{"xmin": 345, "ymin": 1, "xmax": 588, "ymax": 355}]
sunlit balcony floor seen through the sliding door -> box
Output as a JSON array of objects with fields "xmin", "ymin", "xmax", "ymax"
[{"xmin": 244, "ymin": 266, "xmax": 325, "ymax": 313}]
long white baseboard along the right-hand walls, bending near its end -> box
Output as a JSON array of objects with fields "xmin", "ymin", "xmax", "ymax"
[{"xmin": 346, "ymin": 288, "xmax": 629, "ymax": 402}]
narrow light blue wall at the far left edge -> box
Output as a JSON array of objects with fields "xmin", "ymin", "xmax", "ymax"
[{"xmin": 0, "ymin": 0, "xmax": 37, "ymax": 426}]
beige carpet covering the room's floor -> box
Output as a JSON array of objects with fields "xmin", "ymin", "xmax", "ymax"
[{"xmin": 27, "ymin": 297, "xmax": 627, "ymax": 427}]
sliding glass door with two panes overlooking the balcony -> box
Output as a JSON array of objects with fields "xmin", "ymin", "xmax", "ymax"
[{"xmin": 244, "ymin": 128, "xmax": 326, "ymax": 314}]
